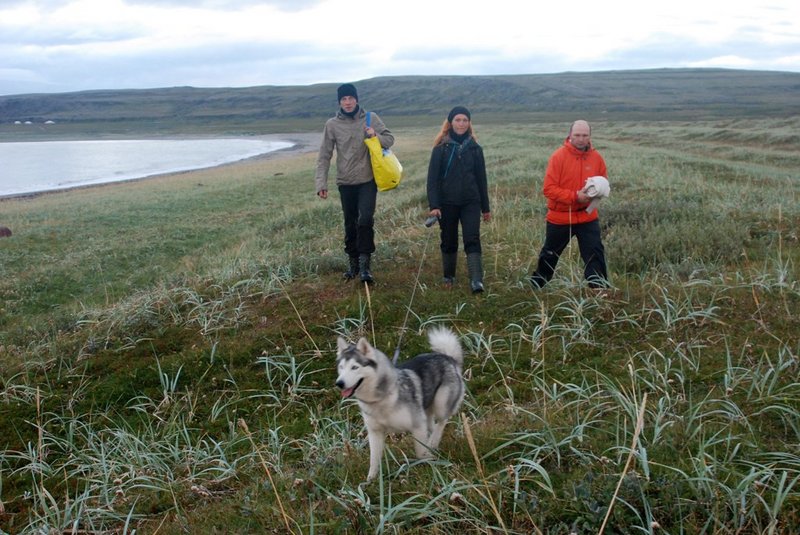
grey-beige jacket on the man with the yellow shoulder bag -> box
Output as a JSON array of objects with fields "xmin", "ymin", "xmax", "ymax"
[{"xmin": 315, "ymin": 109, "xmax": 394, "ymax": 193}]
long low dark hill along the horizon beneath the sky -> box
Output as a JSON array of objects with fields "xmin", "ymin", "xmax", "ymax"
[{"xmin": 0, "ymin": 69, "xmax": 800, "ymax": 124}]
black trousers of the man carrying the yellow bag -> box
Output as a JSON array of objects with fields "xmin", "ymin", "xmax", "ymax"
[{"xmin": 339, "ymin": 180, "xmax": 378, "ymax": 257}]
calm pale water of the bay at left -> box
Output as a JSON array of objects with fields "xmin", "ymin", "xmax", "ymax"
[{"xmin": 0, "ymin": 139, "xmax": 293, "ymax": 196}]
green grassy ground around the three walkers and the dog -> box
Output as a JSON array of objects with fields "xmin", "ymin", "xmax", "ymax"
[{"xmin": 0, "ymin": 117, "xmax": 800, "ymax": 534}]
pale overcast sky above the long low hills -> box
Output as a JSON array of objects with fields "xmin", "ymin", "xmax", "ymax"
[{"xmin": 0, "ymin": 0, "xmax": 800, "ymax": 95}]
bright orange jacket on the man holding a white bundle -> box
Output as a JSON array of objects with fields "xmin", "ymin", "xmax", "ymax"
[{"xmin": 542, "ymin": 137, "xmax": 607, "ymax": 225}]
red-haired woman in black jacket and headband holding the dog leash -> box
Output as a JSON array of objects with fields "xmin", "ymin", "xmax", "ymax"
[{"xmin": 428, "ymin": 106, "xmax": 492, "ymax": 293}]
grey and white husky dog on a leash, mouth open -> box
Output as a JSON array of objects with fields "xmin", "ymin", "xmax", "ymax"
[{"xmin": 336, "ymin": 328, "xmax": 464, "ymax": 481}]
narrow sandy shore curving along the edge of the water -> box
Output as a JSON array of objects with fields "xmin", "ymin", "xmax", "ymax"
[{"xmin": 0, "ymin": 132, "xmax": 322, "ymax": 202}]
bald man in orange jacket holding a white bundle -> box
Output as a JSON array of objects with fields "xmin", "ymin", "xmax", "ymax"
[{"xmin": 530, "ymin": 121, "xmax": 608, "ymax": 288}]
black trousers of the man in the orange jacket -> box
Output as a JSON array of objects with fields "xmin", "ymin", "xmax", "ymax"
[{"xmin": 531, "ymin": 220, "xmax": 608, "ymax": 288}]
